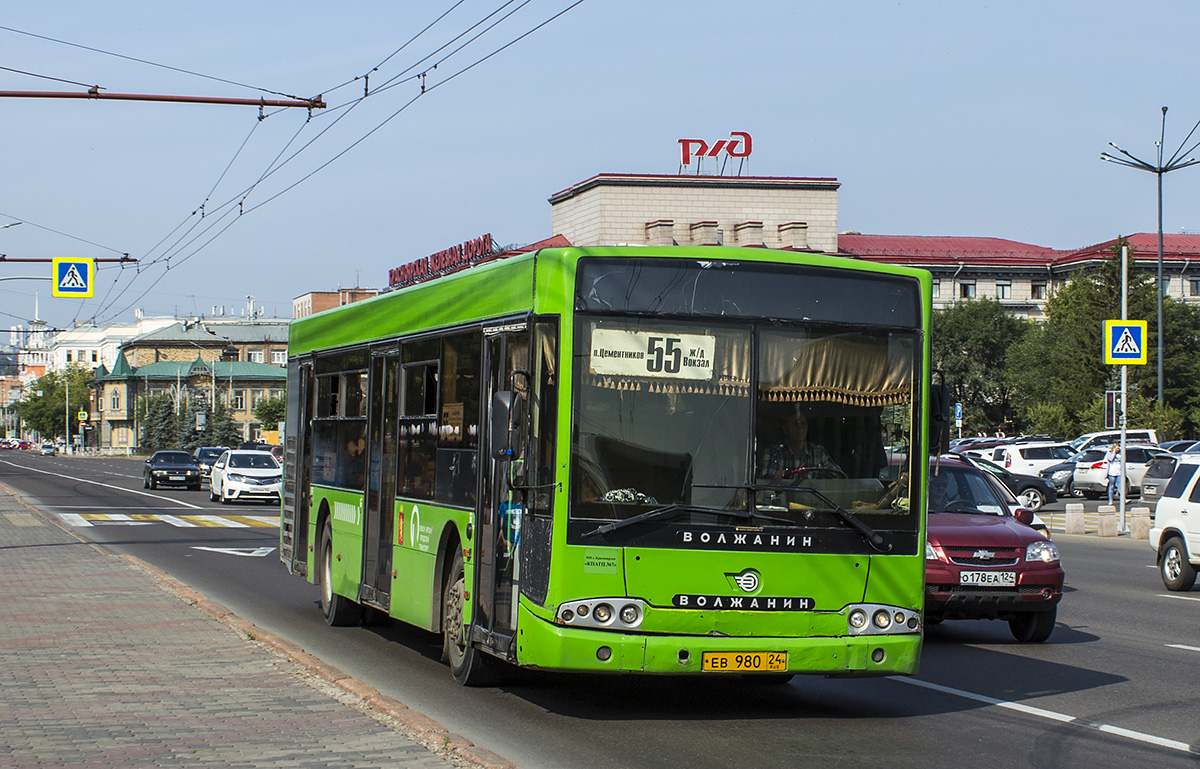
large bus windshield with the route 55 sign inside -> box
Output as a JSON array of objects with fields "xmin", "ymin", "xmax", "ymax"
[{"xmin": 569, "ymin": 261, "xmax": 920, "ymax": 543}]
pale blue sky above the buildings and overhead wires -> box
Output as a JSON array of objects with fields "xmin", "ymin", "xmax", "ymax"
[{"xmin": 0, "ymin": 0, "xmax": 1200, "ymax": 333}]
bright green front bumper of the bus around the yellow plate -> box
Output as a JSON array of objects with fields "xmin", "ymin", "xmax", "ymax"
[{"xmin": 516, "ymin": 606, "xmax": 922, "ymax": 677}]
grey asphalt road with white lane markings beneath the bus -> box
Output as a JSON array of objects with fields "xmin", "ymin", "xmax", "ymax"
[{"xmin": 0, "ymin": 451, "xmax": 1200, "ymax": 769}]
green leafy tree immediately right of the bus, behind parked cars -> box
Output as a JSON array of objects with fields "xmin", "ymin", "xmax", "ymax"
[{"xmin": 932, "ymin": 299, "xmax": 1030, "ymax": 432}]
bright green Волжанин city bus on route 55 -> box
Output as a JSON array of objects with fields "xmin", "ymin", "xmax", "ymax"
[{"xmin": 280, "ymin": 246, "xmax": 943, "ymax": 685}]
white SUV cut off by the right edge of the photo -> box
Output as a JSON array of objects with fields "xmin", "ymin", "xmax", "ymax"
[{"xmin": 1150, "ymin": 458, "xmax": 1200, "ymax": 590}]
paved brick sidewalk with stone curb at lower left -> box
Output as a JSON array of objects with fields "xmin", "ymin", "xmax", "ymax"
[{"xmin": 0, "ymin": 486, "xmax": 510, "ymax": 769}]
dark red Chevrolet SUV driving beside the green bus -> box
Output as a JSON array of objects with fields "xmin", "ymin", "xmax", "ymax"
[{"xmin": 925, "ymin": 456, "xmax": 1063, "ymax": 642}]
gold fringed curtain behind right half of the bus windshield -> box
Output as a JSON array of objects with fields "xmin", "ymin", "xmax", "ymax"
[{"xmin": 758, "ymin": 331, "xmax": 913, "ymax": 405}]
